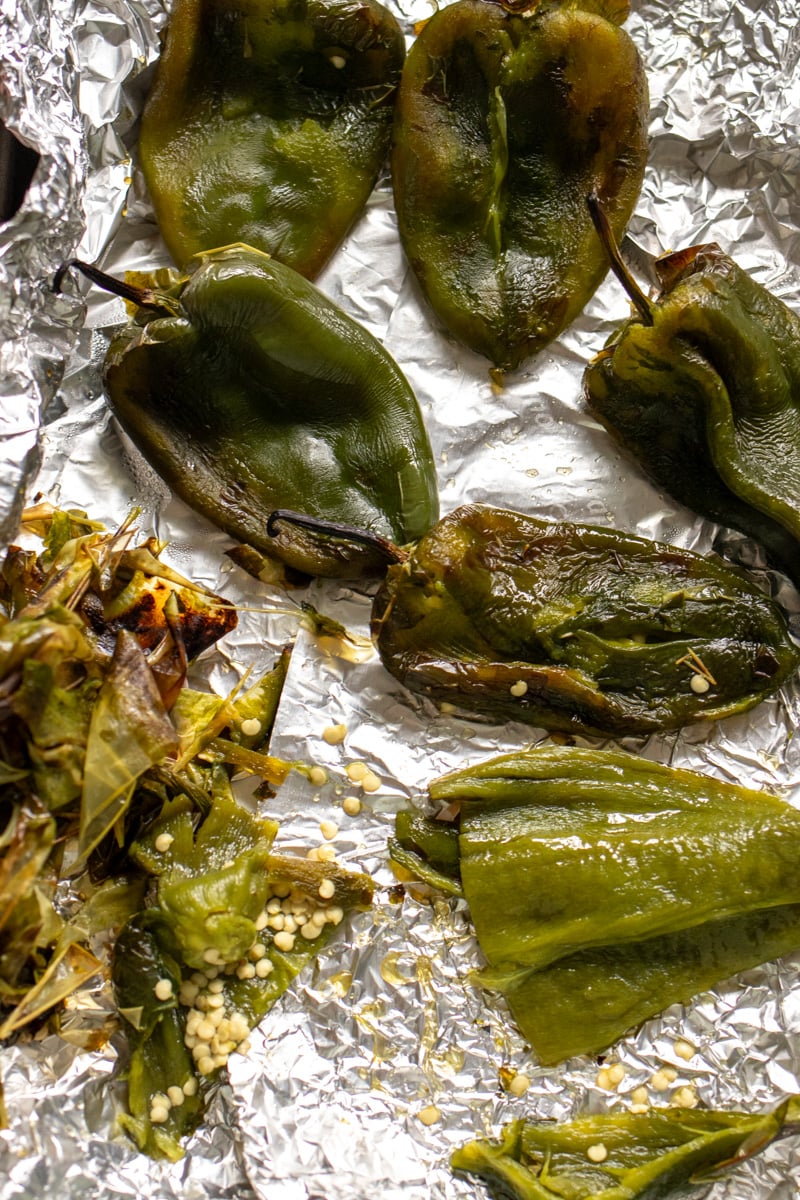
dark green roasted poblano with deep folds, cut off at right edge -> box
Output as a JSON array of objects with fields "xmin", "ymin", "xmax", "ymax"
[{"xmin": 584, "ymin": 244, "xmax": 800, "ymax": 584}]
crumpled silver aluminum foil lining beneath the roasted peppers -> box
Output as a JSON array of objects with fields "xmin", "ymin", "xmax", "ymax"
[{"xmin": 0, "ymin": 0, "xmax": 800, "ymax": 1200}]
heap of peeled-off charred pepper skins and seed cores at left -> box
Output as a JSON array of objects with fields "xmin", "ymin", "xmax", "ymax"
[{"xmin": 0, "ymin": 505, "xmax": 372, "ymax": 1158}]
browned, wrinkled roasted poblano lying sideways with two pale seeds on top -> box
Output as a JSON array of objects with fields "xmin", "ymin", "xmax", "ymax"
[{"xmin": 372, "ymin": 505, "xmax": 799, "ymax": 736}]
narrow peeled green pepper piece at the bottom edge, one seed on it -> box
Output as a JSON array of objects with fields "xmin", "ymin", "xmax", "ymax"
[{"xmin": 450, "ymin": 1098, "xmax": 800, "ymax": 1200}]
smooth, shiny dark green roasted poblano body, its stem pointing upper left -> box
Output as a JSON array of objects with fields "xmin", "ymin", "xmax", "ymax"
[{"xmin": 106, "ymin": 246, "xmax": 438, "ymax": 577}]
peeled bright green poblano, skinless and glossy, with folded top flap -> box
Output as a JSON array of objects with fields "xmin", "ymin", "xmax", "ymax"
[{"xmin": 391, "ymin": 746, "xmax": 800, "ymax": 1063}]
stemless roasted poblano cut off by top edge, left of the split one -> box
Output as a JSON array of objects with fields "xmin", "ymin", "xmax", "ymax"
[{"xmin": 139, "ymin": 0, "xmax": 405, "ymax": 278}]
